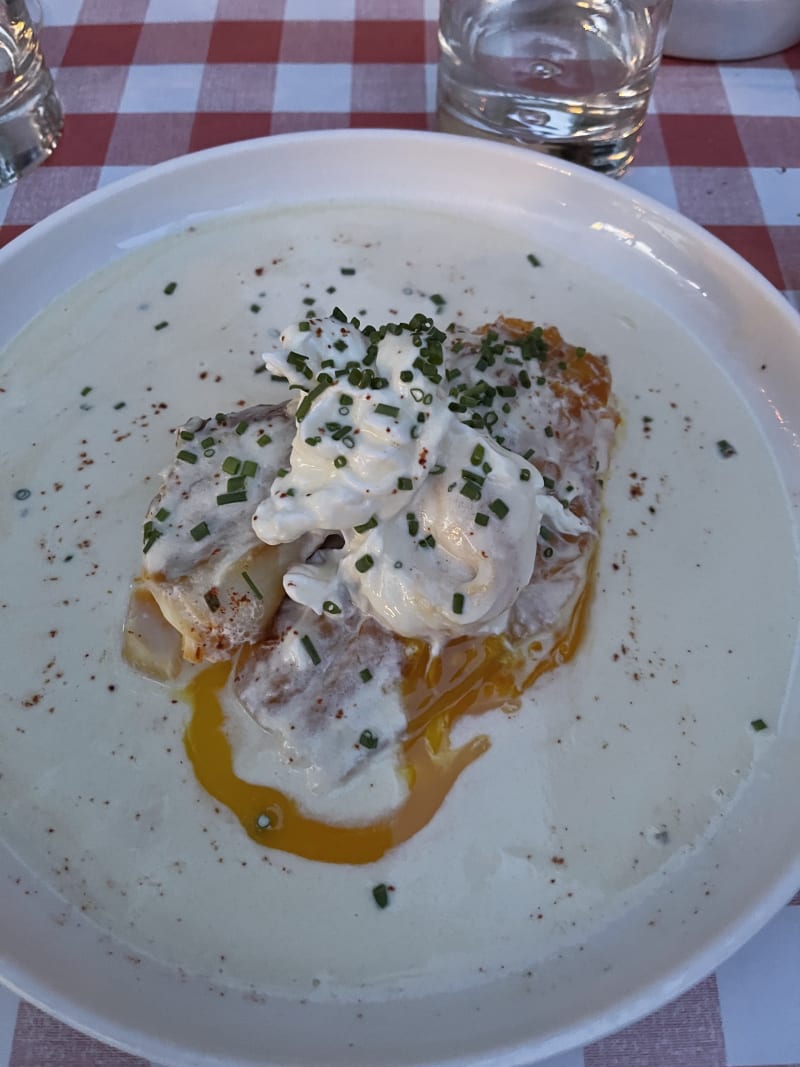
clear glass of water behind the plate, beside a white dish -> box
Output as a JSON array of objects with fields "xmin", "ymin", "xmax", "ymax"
[{"xmin": 437, "ymin": 0, "xmax": 672, "ymax": 177}]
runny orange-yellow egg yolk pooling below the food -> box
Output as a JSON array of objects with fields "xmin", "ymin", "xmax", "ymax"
[{"xmin": 185, "ymin": 571, "xmax": 591, "ymax": 863}]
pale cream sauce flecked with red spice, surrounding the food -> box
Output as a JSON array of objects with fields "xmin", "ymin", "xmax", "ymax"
[{"xmin": 0, "ymin": 206, "xmax": 798, "ymax": 999}]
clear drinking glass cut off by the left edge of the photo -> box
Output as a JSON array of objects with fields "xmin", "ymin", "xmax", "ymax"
[{"xmin": 0, "ymin": 0, "xmax": 64, "ymax": 187}]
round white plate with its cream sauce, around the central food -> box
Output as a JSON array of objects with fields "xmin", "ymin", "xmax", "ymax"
[{"xmin": 0, "ymin": 131, "xmax": 800, "ymax": 1065}]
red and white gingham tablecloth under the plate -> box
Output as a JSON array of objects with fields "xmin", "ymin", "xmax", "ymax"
[{"xmin": 0, "ymin": 0, "xmax": 800, "ymax": 1067}]
